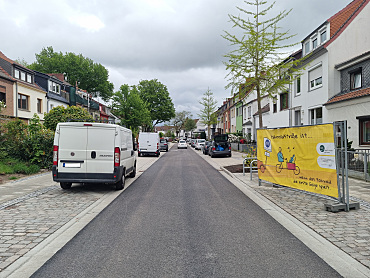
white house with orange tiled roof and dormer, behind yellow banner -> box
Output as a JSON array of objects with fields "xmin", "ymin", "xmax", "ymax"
[{"xmin": 250, "ymin": 0, "xmax": 370, "ymax": 148}]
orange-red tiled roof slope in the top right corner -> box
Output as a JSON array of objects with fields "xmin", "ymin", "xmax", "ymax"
[{"xmin": 325, "ymin": 0, "xmax": 370, "ymax": 47}]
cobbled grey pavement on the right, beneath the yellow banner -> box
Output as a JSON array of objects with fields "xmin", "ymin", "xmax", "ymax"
[{"xmin": 191, "ymin": 148, "xmax": 370, "ymax": 268}]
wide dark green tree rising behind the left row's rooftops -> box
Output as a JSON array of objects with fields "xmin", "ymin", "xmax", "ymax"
[{"xmin": 28, "ymin": 46, "xmax": 114, "ymax": 100}]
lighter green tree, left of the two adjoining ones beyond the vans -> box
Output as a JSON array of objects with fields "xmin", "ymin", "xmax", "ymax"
[{"xmin": 112, "ymin": 84, "xmax": 151, "ymax": 131}]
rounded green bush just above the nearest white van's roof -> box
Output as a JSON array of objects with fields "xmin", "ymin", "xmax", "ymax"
[{"xmin": 44, "ymin": 106, "xmax": 94, "ymax": 131}]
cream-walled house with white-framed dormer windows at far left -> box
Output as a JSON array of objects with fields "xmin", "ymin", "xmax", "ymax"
[{"xmin": 0, "ymin": 51, "xmax": 47, "ymax": 122}]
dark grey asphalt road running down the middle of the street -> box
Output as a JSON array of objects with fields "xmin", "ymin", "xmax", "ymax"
[{"xmin": 32, "ymin": 146, "xmax": 340, "ymax": 278}]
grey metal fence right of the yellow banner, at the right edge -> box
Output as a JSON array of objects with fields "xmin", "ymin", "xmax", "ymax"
[{"xmin": 337, "ymin": 149, "xmax": 370, "ymax": 181}]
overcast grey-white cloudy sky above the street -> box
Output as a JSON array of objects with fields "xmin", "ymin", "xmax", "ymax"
[{"xmin": 0, "ymin": 0, "xmax": 351, "ymax": 118}]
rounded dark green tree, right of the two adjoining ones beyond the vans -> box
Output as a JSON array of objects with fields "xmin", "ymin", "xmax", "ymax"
[{"xmin": 137, "ymin": 79, "xmax": 175, "ymax": 128}]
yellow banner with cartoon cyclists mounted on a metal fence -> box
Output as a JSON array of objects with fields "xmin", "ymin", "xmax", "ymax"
[{"xmin": 257, "ymin": 124, "xmax": 338, "ymax": 197}]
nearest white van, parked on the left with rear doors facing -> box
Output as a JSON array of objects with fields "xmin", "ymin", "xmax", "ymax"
[{"xmin": 52, "ymin": 122, "xmax": 136, "ymax": 190}]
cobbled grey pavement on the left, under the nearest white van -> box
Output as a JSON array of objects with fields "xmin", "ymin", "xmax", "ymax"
[{"xmin": 0, "ymin": 153, "xmax": 163, "ymax": 278}]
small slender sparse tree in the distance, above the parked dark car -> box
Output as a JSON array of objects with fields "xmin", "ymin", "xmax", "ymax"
[{"xmin": 198, "ymin": 89, "xmax": 217, "ymax": 139}]
